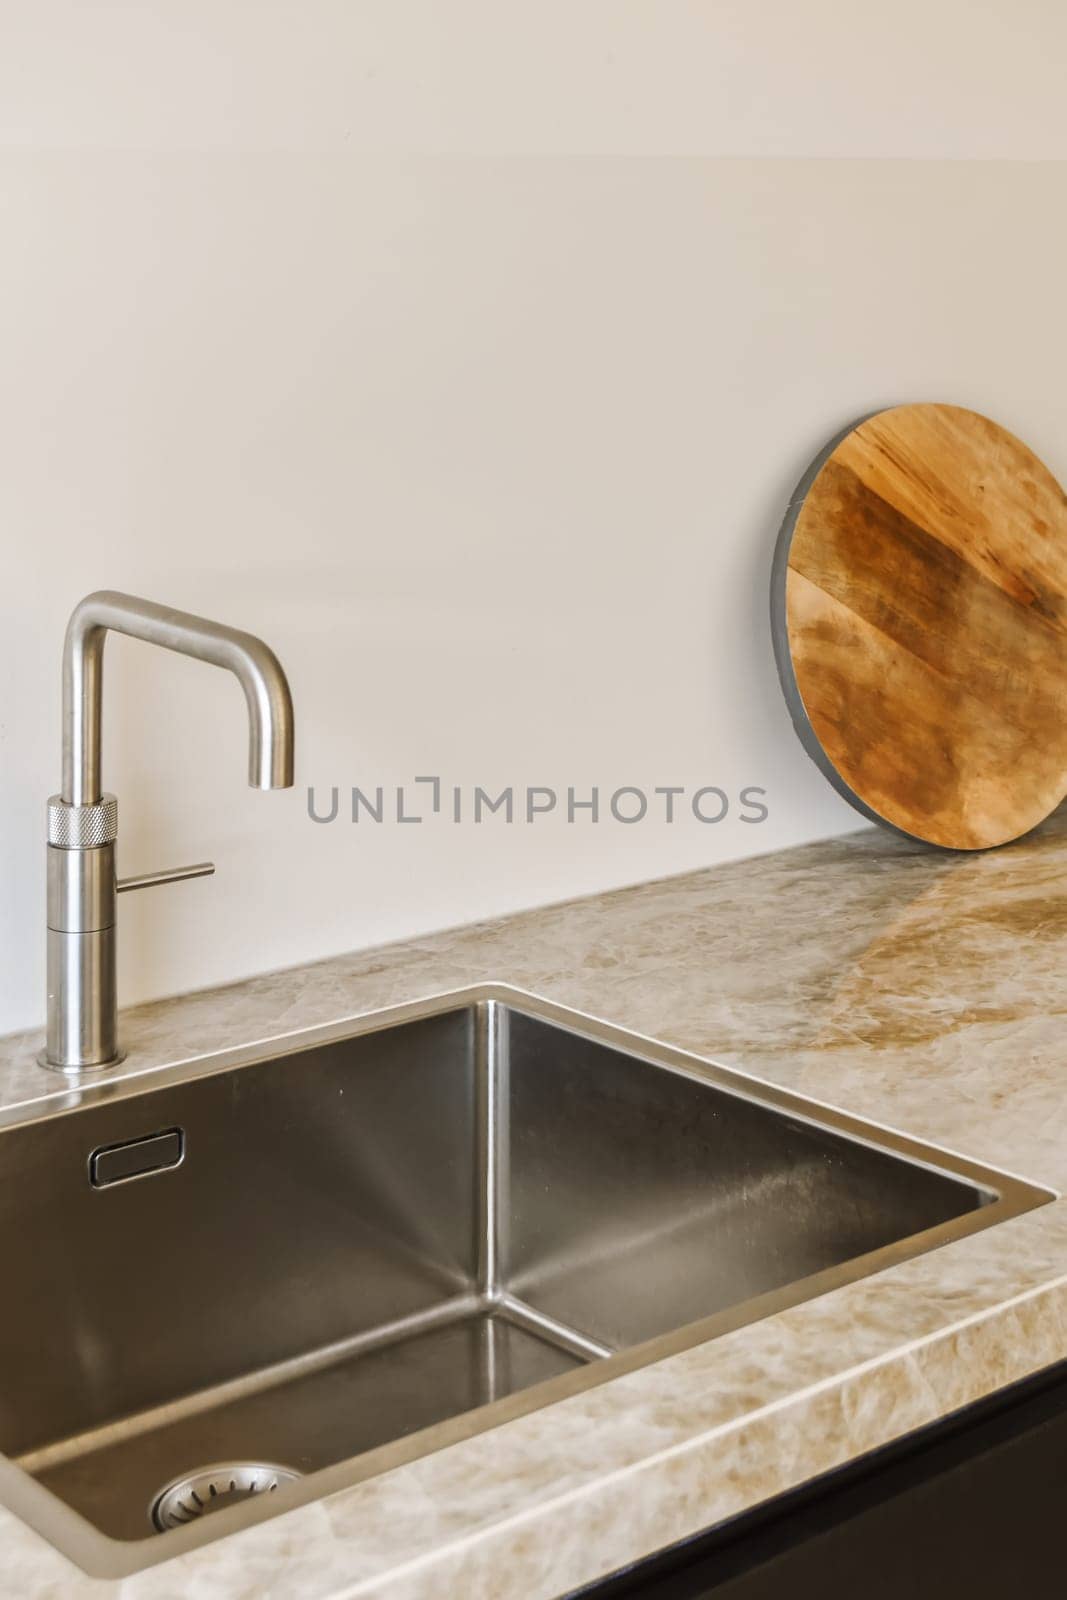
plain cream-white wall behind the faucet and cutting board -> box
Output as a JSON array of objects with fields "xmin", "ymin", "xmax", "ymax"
[{"xmin": 0, "ymin": 0, "xmax": 1067, "ymax": 1029}]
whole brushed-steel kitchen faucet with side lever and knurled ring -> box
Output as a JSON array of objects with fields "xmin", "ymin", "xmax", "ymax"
[{"xmin": 37, "ymin": 589, "xmax": 293, "ymax": 1072}]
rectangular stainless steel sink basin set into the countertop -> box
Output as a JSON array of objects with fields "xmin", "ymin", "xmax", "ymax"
[{"xmin": 0, "ymin": 987, "xmax": 1049, "ymax": 1576}]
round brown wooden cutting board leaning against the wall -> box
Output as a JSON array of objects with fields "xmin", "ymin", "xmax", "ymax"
[{"xmin": 771, "ymin": 405, "xmax": 1067, "ymax": 850}]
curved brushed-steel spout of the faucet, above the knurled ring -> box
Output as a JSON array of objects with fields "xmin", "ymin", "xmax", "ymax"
[{"xmin": 62, "ymin": 589, "xmax": 293, "ymax": 805}]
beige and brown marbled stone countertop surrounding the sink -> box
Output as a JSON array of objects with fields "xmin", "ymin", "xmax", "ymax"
[{"xmin": 0, "ymin": 816, "xmax": 1067, "ymax": 1600}]
